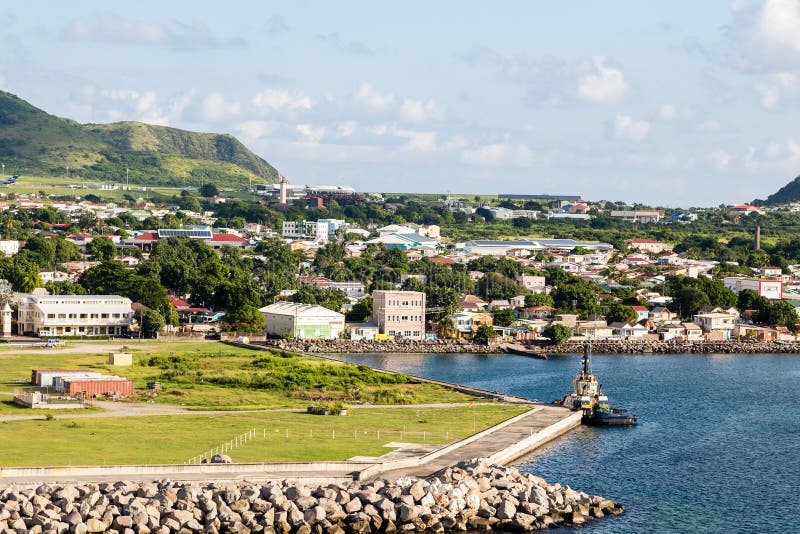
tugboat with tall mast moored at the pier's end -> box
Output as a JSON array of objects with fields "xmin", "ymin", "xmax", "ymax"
[{"xmin": 560, "ymin": 343, "xmax": 637, "ymax": 426}]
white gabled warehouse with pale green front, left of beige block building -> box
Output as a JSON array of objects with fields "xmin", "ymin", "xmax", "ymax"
[{"xmin": 258, "ymin": 302, "xmax": 344, "ymax": 339}]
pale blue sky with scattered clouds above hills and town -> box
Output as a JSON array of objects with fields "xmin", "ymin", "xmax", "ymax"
[{"xmin": 0, "ymin": 0, "xmax": 800, "ymax": 207}]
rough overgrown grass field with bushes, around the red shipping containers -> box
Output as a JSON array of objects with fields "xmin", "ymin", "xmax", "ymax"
[{"xmin": 0, "ymin": 342, "xmax": 474, "ymax": 410}]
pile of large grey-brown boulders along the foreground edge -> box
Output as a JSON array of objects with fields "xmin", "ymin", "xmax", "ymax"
[{"xmin": 0, "ymin": 460, "xmax": 623, "ymax": 534}]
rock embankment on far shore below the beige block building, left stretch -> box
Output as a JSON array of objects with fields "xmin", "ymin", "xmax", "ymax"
[{"xmin": 264, "ymin": 339, "xmax": 499, "ymax": 354}]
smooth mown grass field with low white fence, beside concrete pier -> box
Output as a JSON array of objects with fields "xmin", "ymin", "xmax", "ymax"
[{"xmin": 0, "ymin": 405, "xmax": 525, "ymax": 466}]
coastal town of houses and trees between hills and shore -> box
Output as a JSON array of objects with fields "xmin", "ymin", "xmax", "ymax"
[{"xmin": 0, "ymin": 184, "xmax": 800, "ymax": 351}]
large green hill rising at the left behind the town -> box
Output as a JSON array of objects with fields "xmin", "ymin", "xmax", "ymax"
[{"xmin": 0, "ymin": 91, "xmax": 278, "ymax": 191}]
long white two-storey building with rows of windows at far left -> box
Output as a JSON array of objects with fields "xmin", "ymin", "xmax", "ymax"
[{"xmin": 17, "ymin": 295, "xmax": 133, "ymax": 336}]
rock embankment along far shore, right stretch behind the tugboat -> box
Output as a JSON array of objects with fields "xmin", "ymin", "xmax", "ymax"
[{"xmin": 532, "ymin": 340, "xmax": 800, "ymax": 354}]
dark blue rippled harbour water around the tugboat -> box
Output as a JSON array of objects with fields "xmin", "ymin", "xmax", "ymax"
[{"xmin": 332, "ymin": 354, "xmax": 800, "ymax": 533}]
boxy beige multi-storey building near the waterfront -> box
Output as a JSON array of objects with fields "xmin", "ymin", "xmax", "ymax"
[{"xmin": 372, "ymin": 290, "xmax": 425, "ymax": 339}]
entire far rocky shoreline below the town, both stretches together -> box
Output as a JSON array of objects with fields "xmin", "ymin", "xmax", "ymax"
[{"xmin": 255, "ymin": 339, "xmax": 800, "ymax": 354}]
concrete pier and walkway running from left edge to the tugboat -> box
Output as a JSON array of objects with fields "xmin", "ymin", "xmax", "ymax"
[{"xmin": 0, "ymin": 405, "xmax": 581, "ymax": 486}]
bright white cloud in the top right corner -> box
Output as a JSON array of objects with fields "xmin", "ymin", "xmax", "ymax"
[{"xmin": 726, "ymin": 0, "xmax": 800, "ymax": 71}]
